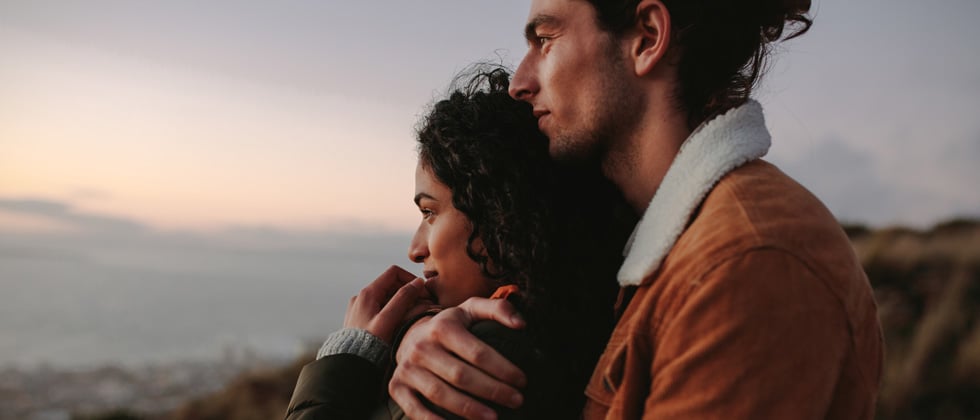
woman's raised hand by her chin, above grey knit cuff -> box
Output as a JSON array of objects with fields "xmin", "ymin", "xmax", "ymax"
[{"xmin": 344, "ymin": 265, "xmax": 432, "ymax": 344}]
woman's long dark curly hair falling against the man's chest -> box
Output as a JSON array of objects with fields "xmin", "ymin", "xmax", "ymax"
[{"xmin": 418, "ymin": 65, "xmax": 635, "ymax": 418}]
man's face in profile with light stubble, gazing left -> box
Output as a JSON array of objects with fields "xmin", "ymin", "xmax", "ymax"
[{"xmin": 510, "ymin": 0, "xmax": 638, "ymax": 160}]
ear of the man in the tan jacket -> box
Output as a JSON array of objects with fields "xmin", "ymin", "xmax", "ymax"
[{"xmin": 630, "ymin": 0, "xmax": 671, "ymax": 76}]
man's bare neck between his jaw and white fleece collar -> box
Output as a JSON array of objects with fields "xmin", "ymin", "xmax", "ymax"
[{"xmin": 603, "ymin": 104, "xmax": 691, "ymax": 215}]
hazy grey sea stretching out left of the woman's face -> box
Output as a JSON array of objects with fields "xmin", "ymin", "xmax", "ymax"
[{"xmin": 0, "ymin": 230, "xmax": 419, "ymax": 369}]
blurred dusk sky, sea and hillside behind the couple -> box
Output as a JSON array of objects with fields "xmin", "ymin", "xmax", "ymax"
[{"xmin": 0, "ymin": 0, "xmax": 980, "ymax": 419}]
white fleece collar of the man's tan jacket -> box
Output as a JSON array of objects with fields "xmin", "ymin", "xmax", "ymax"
[{"xmin": 618, "ymin": 99, "xmax": 770, "ymax": 286}]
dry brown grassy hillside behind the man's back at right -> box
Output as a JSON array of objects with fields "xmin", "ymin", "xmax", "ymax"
[{"xmin": 847, "ymin": 220, "xmax": 980, "ymax": 419}]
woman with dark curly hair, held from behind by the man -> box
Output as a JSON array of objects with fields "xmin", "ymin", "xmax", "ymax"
[{"xmin": 288, "ymin": 68, "xmax": 634, "ymax": 418}]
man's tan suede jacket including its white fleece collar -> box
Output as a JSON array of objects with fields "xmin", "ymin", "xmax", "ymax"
[{"xmin": 584, "ymin": 102, "xmax": 883, "ymax": 419}]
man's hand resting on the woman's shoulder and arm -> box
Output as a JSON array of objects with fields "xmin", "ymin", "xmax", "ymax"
[{"xmin": 388, "ymin": 298, "xmax": 527, "ymax": 419}]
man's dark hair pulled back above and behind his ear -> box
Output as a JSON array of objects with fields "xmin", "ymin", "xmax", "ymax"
[{"xmin": 589, "ymin": 0, "xmax": 812, "ymax": 128}]
